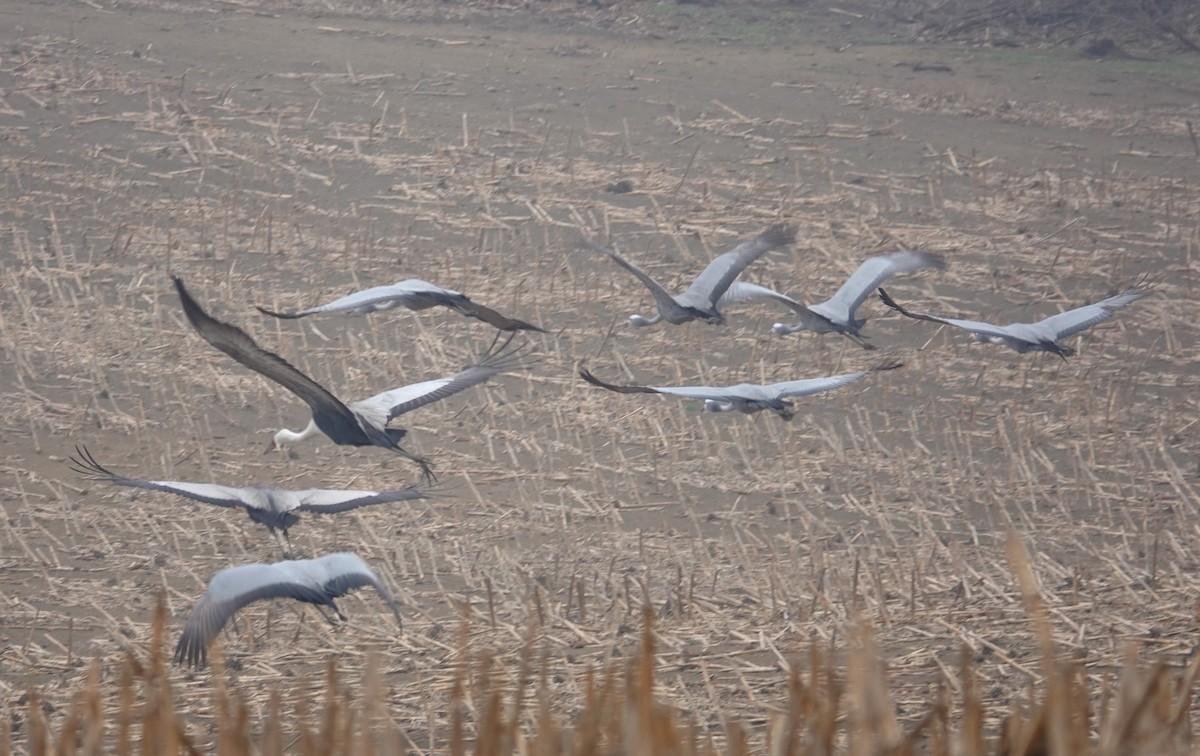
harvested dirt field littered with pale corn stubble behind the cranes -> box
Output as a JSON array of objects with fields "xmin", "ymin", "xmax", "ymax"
[{"xmin": 0, "ymin": 0, "xmax": 1200, "ymax": 750}]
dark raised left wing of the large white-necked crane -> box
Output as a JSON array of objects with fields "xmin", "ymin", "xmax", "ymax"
[{"xmin": 170, "ymin": 276, "xmax": 353, "ymax": 419}]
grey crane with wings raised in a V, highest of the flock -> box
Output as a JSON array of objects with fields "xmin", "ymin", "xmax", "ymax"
[{"xmin": 583, "ymin": 226, "xmax": 796, "ymax": 326}]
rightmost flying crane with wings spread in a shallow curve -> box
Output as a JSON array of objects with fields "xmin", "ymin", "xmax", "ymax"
[{"xmin": 880, "ymin": 278, "xmax": 1153, "ymax": 361}]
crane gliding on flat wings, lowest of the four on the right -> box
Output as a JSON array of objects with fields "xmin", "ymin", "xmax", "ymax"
[{"xmin": 580, "ymin": 362, "xmax": 902, "ymax": 420}]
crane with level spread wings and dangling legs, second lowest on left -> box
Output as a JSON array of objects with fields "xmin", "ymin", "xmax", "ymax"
[{"xmin": 71, "ymin": 446, "xmax": 428, "ymax": 559}]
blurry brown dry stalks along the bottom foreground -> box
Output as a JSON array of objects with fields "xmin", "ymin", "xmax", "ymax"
[{"xmin": 11, "ymin": 536, "xmax": 1200, "ymax": 756}]
